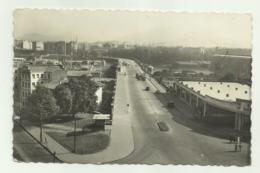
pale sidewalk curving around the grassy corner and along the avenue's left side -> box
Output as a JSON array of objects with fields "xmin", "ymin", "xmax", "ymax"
[{"xmin": 21, "ymin": 68, "xmax": 134, "ymax": 163}]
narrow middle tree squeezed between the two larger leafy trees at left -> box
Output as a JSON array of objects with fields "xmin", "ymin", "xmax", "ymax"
[{"xmin": 54, "ymin": 84, "xmax": 72, "ymax": 113}]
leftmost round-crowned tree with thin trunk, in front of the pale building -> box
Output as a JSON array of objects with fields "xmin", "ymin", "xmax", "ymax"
[{"xmin": 23, "ymin": 86, "xmax": 59, "ymax": 142}]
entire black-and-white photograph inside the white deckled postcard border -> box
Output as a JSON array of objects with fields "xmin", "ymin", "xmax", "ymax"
[{"xmin": 12, "ymin": 9, "xmax": 252, "ymax": 166}]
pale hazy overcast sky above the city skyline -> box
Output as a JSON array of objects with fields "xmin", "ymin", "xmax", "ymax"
[{"xmin": 14, "ymin": 10, "xmax": 252, "ymax": 48}]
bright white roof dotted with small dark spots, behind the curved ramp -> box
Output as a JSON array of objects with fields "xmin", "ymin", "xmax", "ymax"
[{"xmin": 183, "ymin": 81, "xmax": 251, "ymax": 102}]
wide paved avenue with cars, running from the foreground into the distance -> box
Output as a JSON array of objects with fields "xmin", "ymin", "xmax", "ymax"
[{"xmin": 115, "ymin": 60, "xmax": 248, "ymax": 165}]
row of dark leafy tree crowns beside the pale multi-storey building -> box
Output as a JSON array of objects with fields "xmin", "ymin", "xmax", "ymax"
[{"xmin": 22, "ymin": 76, "xmax": 97, "ymax": 120}]
